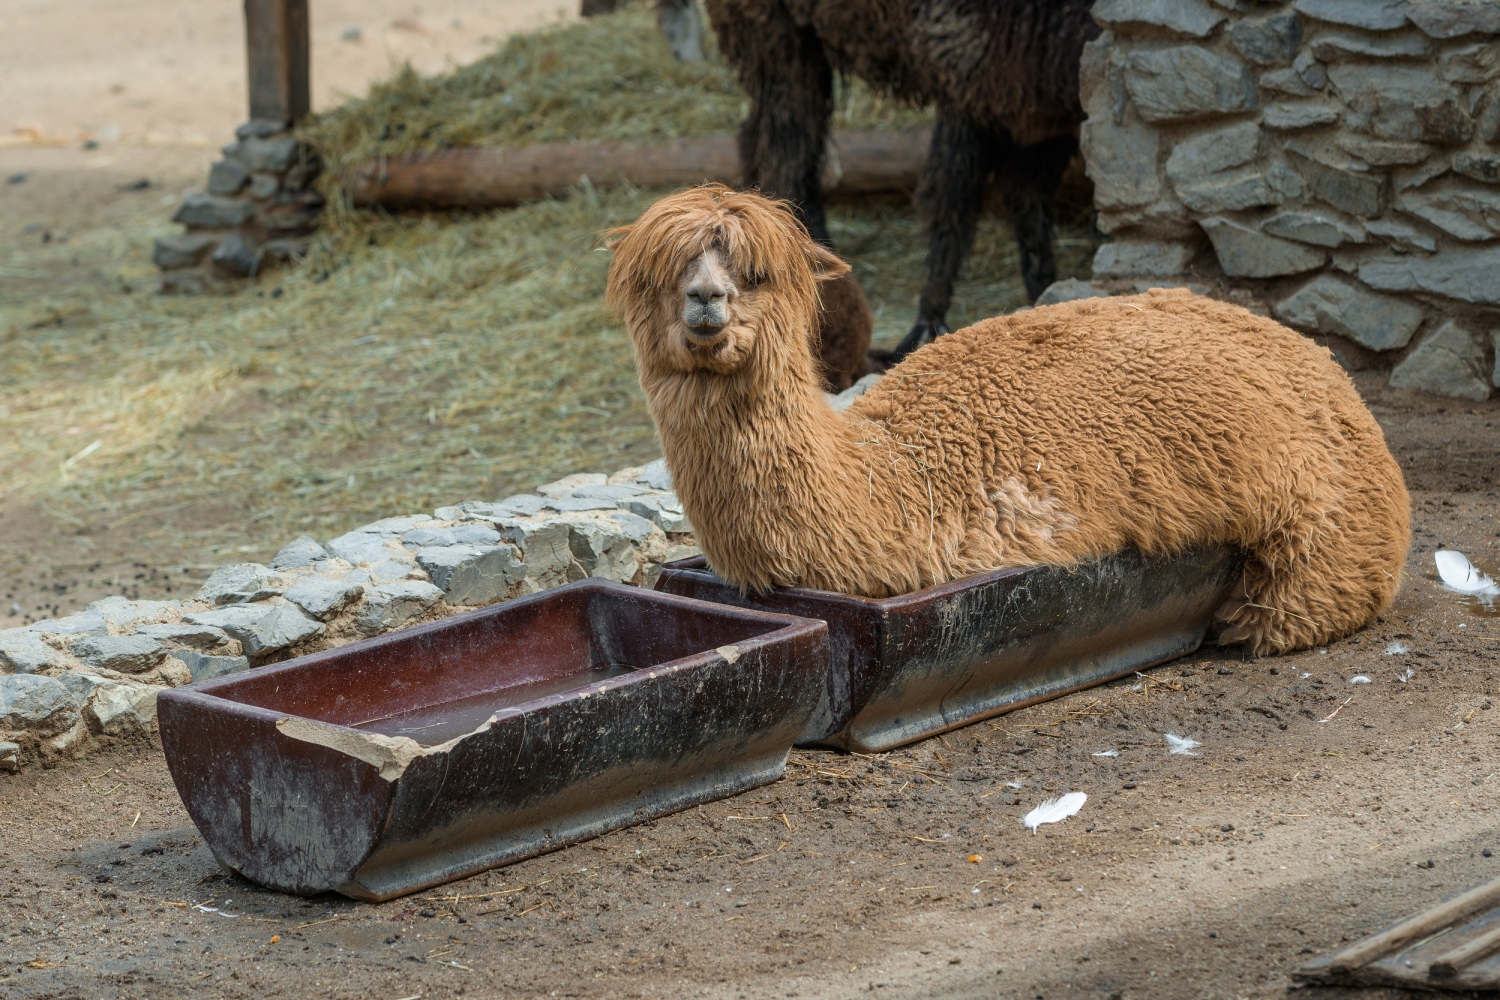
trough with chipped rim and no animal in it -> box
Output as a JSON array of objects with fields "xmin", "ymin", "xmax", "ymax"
[{"xmin": 158, "ymin": 580, "xmax": 828, "ymax": 901}]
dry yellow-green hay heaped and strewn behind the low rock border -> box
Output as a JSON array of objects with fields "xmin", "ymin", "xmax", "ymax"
[{"xmin": 0, "ymin": 0, "xmax": 1095, "ymax": 575}]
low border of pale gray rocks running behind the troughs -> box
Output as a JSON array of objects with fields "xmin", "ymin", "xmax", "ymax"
[{"xmin": 0, "ymin": 459, "xmax": 698, "ymax": 771}]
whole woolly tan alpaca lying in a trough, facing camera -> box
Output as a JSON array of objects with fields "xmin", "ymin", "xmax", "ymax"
[{"xmin": 609, "ymin": 186, "xmax": 1409, "ymax": 654}]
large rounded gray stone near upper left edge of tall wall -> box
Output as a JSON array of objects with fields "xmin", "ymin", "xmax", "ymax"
[{"xmin": 1125, "ymin": 45, "xmax": 1259, "ymax": 121}]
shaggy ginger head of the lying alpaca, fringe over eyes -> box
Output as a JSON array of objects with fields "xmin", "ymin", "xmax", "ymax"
[{"xmin": 608, "ymin": 184, "xmax": 849, "ymax": 378}]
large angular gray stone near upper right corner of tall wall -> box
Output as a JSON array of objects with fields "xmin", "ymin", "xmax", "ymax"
[{"xmin": 1329, "ymin": 63, "xmax": 1475, "ymax": 145}]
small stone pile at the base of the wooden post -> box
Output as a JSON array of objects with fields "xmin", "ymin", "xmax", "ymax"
[{"xmin": 152, "ymin": 121, "xmax": 324, "ymax": 294}]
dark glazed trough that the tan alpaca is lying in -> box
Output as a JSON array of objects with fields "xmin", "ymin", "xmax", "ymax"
[{"xmin": 657, "ymin": 549, "xmax": 1241, "ymax": 753}]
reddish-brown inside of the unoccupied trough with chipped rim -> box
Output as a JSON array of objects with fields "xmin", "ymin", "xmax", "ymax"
[{"xmin": 193, "ymin": 589, "xmax": 774, "ymax": 747}]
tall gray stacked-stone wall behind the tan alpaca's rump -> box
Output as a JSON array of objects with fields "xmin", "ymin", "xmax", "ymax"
[{"xmin": 1080, "ymin": 0, "xmax": 1500, "ymax": 400}]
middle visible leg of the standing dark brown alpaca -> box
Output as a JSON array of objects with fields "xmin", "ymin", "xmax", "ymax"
[{"xmin": 891, "ymin": 108, "xmax": 996, "ymax": 364}]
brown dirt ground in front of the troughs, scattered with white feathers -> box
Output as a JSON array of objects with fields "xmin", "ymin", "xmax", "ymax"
[{"xmin": 0, "ymin": 375, "xmax": 1500, "ymax": 1000}]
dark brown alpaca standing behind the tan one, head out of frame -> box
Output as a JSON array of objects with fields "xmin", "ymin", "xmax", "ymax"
[{"xmin": 707, "ymin": 0, "xmax": 1098, "ymax": 364}]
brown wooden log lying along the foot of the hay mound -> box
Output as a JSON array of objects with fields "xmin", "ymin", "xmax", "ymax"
[{"xmin": 351, "ymin": 129, "xmax": 932, "ymax": 210}]
